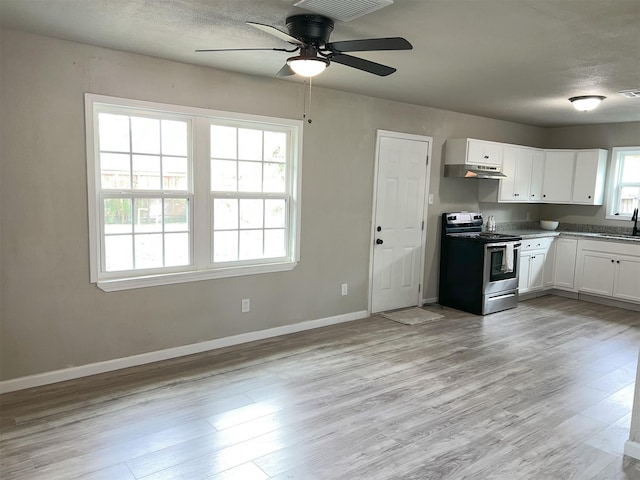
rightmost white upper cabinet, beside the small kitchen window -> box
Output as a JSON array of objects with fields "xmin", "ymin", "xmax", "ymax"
[{"xmin": 571, "ymin": 150, "xmax": 607, "ymax": 205}]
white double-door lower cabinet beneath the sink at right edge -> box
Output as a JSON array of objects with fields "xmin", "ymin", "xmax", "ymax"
[{"xmin": 576, "ymin": 240, "xmax": 640, "ymax": 303}]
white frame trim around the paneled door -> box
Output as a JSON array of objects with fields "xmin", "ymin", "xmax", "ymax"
[{"xmin": 367, "ymin": 130, "xmax": 433, "ymax": 315}]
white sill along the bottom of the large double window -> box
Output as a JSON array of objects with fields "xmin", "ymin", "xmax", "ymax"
[{"xmin": 97, "ymin": 262, "xmax": 298, "ymax": 292}]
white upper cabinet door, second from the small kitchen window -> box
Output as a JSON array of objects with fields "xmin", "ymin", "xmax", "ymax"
[{"xmin": 542, "ymin": 150, "xmax": 575, "ymax": 203}]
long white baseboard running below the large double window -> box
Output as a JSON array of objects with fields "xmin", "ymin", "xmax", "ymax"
[{"xmin": 0, "ymin": 310, "xmax": 369, "ymax": 394}]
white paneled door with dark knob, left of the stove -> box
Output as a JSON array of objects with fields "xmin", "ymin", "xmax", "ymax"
[{"xmin": 371, "ymin": 132, "xmax": 431, "ymax": 313}]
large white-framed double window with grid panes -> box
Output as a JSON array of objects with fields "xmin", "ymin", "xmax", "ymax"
[{"xmin": 85, "ymin": 93, "xmax": 302, "ymax": 291}]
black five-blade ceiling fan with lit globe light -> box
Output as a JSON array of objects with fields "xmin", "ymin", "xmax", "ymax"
[{"xmin": 196, "ymin": 14, "xmax": 413, "ymax": 77}]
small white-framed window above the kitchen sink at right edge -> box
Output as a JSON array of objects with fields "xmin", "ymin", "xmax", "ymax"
[{"xmin": 607, "ymin": 146, "xmax": 640, "ymax": 220}]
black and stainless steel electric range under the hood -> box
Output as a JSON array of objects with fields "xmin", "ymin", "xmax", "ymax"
[{"xmin": 439, "ymin": 212, "xmax": 522, "ymax": 315}]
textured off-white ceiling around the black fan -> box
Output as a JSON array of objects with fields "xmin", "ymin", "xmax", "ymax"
[{"xmin": 0, "ymin": 0, "xmax": 640, "ymax": 126}]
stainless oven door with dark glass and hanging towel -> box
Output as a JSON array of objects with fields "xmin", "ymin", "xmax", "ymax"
[{"xmin": 483, "ymin": 242, "xmax": 521, "ymax": 293}]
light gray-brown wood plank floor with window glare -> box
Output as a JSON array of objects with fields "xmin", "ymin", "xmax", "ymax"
[{"xmin": 0, "ymin": 296, "xmax": 640, "ymax": 480}]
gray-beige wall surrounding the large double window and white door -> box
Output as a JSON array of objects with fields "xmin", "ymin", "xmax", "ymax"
[{"xmin": 0, "ymin": 30, "xmax": 632, "ymax": 380}]
